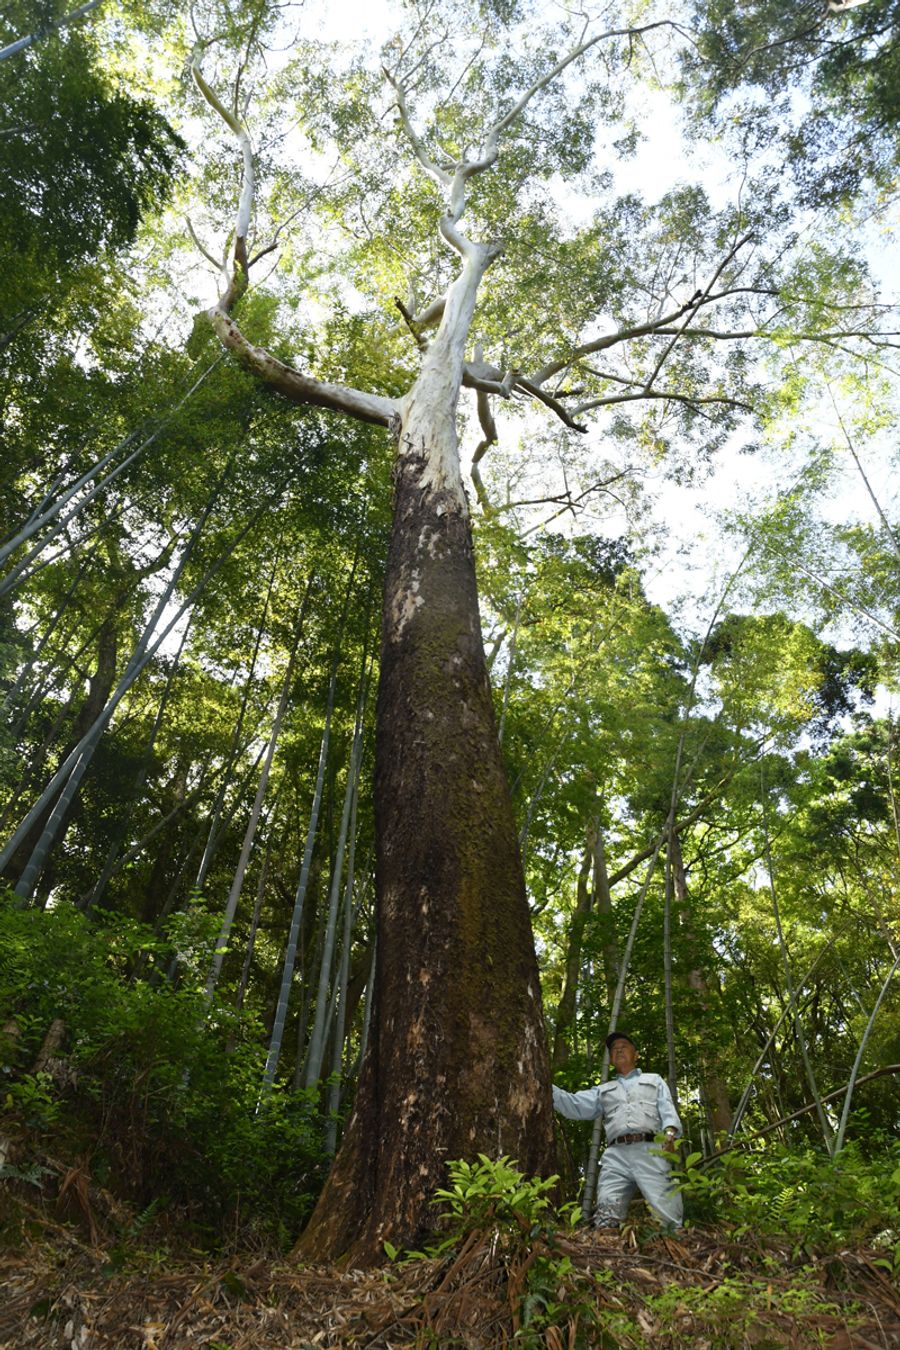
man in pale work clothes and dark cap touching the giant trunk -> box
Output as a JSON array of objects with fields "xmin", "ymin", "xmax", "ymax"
[{"xmin": 553, "ymin": 1031, "xmax": 683, "ymax": 1229}]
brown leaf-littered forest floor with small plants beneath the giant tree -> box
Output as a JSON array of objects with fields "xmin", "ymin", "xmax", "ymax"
[{"xmin": 0, "ymin": 1183, "xmax": 900, "ymax": 1350}]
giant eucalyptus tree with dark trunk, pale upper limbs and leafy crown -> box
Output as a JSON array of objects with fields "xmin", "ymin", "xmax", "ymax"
[{"xmin": 93, "ymin": 4, "xmax": 895, "ymax": 1256}]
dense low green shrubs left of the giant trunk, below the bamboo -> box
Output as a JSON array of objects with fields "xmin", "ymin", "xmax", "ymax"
[{"xmin": 0, "ymin": 898, "xmax": 327, "ymax": 1242}]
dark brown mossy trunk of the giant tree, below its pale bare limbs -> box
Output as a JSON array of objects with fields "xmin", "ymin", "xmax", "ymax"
[{"xmin": 300, "ymin": 436, "xmax": 553, "ymax": 1262}]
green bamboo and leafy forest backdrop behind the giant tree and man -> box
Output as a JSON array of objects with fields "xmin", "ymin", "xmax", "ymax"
[{"xmin": 0, "ymin": 0, "xmax": 900, "ymax": 1285}]
